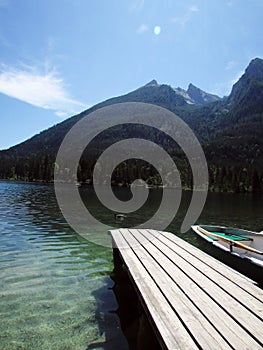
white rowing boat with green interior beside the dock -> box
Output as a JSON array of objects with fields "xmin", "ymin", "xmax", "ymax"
[{"xmin": 192, "ymin": 225, "xmax": 263, "ymax": 267}]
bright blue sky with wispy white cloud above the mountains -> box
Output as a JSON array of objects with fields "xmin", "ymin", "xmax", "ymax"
[{"xmin": 0, "ymin": 0, "xmax": 263, "ymax": 149}]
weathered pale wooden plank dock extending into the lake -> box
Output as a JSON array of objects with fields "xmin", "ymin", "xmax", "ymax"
[{"xmin": 109, "ymin": 229, "xmax": 263, "ymax": 350}]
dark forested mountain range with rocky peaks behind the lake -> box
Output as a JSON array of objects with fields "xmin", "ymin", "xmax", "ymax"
[{"xmin": 0, "ymin": 58, "xmax": 263, "ymax": 192}]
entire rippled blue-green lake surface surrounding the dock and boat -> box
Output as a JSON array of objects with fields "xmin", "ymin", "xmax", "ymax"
[{"xmin": 0, "ymin": 181, "xmax": 263, "ymax": 350}]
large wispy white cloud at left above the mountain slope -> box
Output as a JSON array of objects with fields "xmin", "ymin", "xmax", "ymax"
[{"xmin": 0, "ymin": 64, "xmax": 85, "ymax": 117}]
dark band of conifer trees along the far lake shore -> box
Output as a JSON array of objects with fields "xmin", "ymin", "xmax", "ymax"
[{"xmin": 0, "ymin": 155, "xmax": 263, "ymax": 193}]
